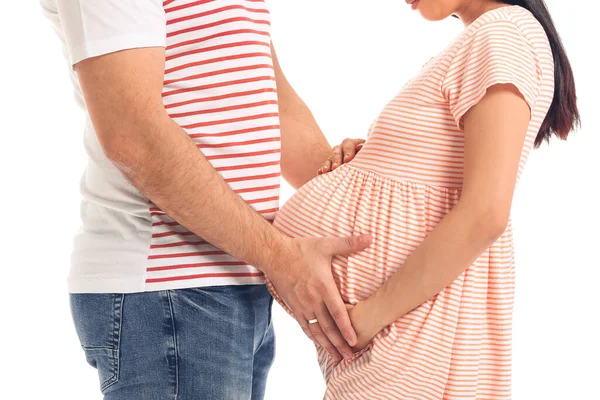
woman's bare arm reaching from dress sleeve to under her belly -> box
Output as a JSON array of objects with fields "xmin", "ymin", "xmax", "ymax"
[{"xmin": 350, "ymin": 85, "xmax": 530, "ymax": 348}]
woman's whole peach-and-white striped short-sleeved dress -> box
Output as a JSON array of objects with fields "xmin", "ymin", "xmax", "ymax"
[{"xmin": 270, "ymin": 6, "xmax": 554, "ymax": 400}]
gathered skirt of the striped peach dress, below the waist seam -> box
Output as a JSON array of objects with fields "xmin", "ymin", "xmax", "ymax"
[{"xmin": 269, "ymin": 164, "xmax": 514, "ymax": 399}]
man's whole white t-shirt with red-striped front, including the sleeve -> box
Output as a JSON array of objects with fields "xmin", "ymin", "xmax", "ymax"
[{"xmin": 41, "ymin": 0, "xmax": 281, "ymax": 293}]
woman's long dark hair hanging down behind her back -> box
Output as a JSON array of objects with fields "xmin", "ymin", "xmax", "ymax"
[{"xmin": 499, "ymin": 0, "xmax": 580, "ymax": 147}]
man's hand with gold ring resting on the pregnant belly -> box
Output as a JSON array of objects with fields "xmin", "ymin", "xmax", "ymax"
[{"xmin": 267, "ymin": 235, "xmax": 371, "ymax": 360}]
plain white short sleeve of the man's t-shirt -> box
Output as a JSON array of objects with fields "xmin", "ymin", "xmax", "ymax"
[{"xmin": 57, "ymin": 0, "xmax": 166, "ymax": 65}]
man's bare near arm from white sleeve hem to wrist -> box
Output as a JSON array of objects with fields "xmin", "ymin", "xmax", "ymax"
[{"xmin": 74, "ymin": 47, "xmax": 286, "ymax": 271}]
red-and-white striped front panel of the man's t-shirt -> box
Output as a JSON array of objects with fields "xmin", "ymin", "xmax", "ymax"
[{"xmin": 146, "ymin": 0, "xmax": 280, "ymax": 290}]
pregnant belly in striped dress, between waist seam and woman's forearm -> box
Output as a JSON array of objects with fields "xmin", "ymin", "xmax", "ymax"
[{"xmin": 274, "ymin": 165, "xmax": 458, "ymax": 303}]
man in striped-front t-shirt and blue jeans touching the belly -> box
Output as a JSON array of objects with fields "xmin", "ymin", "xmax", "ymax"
[{"xmin": 42, "ymin": 0, "xmax": 369, "ymax": 400}]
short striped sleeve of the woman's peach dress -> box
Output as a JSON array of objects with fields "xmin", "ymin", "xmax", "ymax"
[{"xmin": 442, "ymin": 20, "xmax": 541, "ymax": 129}]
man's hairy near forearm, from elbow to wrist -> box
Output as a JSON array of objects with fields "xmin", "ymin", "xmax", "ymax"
[{"xmin": 107, "ymin": 114, "xmax": 286, "ymax": 271}]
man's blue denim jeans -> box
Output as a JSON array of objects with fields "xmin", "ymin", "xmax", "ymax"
[{"xmin": 71, "ymin": 285, "xmax": 275, "ymax": 400}]
